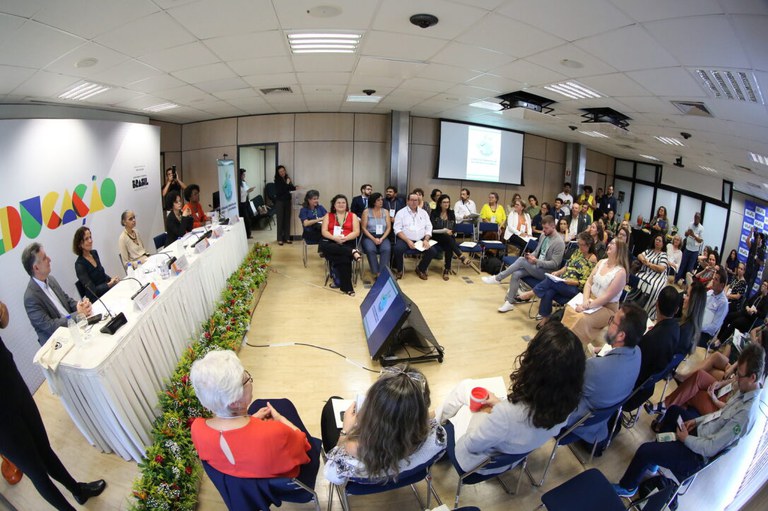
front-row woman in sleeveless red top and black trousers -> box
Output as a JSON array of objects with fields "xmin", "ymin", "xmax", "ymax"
[{"xmin": 321, "ymin": 194, "xmax": 360, "ymax": 296}]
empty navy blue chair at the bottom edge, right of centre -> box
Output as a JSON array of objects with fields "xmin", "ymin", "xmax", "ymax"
[{"xmin": 539, "ymin": 468, "xmax": 625, "ymax": 511}]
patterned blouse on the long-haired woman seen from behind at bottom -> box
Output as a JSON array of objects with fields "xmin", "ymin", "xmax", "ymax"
[{"xmin": 325, "ymin": 419, "xmax": 446, "ymax": 484}]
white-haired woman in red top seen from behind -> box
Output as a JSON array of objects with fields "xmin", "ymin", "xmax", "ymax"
[{"xmin": 190, "ymin": 350, "xmax": 311, "ymax": 478}]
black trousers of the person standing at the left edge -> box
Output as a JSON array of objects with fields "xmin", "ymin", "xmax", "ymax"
[{"xmin": 0, "ymin": 339, "xmax": 79, "ymax": 511}]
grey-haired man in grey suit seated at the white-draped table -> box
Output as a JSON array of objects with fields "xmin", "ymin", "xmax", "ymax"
[{"xmin": 21, "ymin": 243, "xmax": 91, "ymax": 346}]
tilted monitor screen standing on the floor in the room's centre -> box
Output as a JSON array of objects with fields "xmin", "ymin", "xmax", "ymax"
[{"xmin": 360, "ymin": 268, "xmax": 411, "ymax": 360}]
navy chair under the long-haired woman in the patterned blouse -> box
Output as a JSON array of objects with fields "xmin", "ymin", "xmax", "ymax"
[{"xmin": 328, "ymin": 452, "xmax": 443, "ymax": 511}]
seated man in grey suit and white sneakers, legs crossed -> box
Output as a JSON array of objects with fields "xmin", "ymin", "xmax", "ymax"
[{"xmin": 483, "ymin": 215, "xmax": 565, "ymax": 312}]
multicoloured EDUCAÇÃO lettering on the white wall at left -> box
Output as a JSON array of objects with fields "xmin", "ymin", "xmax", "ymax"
[{"xmin": 0, "ymin": 176, "xmax": 117, "ymax": 255}]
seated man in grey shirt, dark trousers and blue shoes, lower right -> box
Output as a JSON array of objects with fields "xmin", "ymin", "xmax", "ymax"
[{"xmin": 614, "ymin": 344, "xmax": 765, "ymax": 497}]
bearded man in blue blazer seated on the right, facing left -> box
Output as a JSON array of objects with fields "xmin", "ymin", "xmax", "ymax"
[{"xmin": 568, "ymin": 303, "xmax": 648, "ymax": 448}]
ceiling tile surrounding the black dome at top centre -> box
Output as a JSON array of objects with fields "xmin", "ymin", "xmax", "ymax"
[{"xmin": 373, "ymin": 0, "xmax": 488, "ymax": 39}]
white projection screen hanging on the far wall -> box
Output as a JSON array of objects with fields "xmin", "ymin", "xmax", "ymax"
[{"xmin": 437, "ymin": 120, "xmax": 524, "ymax": 185}]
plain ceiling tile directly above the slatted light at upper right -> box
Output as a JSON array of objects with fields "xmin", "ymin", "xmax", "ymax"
[{"xmin": 645, "ymin": 16, "xmax": 748, "ymax": 68}]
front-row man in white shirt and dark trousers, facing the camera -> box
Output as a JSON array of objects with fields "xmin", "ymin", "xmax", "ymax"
[{"xmin": 393, "ymin": 193, "xmax": 437, "ymax": 280}]
